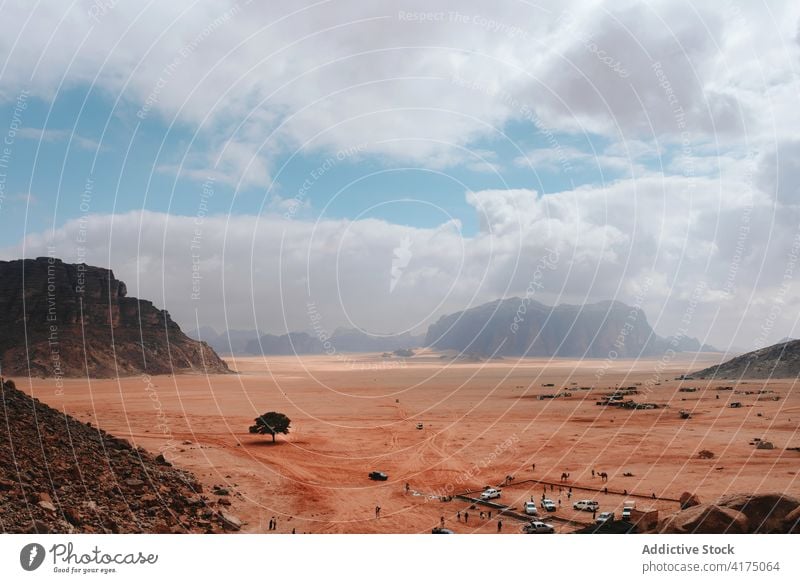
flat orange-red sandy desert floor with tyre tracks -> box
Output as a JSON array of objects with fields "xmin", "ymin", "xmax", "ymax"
[{"xmin": 18, "ymin": 354, "xmax": 800, "ymax": 533}]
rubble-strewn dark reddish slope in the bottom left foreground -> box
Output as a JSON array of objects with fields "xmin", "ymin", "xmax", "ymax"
[{"xmin": 0, "ymin": 380, "xmax": 238, "ymax": 533}]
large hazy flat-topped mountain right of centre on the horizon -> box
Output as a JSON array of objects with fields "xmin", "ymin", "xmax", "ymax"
[{"xmin": 425, "ymin": 298, "xmax": 699, "ymax": 359}]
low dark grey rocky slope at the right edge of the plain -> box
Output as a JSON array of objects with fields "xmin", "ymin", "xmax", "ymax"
[{"xmin": 692, "ymin": 340, "xmax": 800, "ymax": 379}]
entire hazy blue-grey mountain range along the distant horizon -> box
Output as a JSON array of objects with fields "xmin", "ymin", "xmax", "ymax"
[{"xmin": 194, "ymin": 298, "xmax": 717, "ymax": 358}]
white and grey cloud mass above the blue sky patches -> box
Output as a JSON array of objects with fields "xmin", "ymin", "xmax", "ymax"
[{"xmin": 0, "ymin": 0, "xmax": 800, "ymax": 184}]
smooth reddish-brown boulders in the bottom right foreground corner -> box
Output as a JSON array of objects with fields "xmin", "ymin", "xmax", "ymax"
[{"xmin": 657, "ymin": 494, "xmax": 800, "ymax": 534}]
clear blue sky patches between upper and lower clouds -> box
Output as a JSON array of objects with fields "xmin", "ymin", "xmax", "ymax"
[{"xmin": 0, "ymin": 86, "xmax": 636, "ymax": 246}]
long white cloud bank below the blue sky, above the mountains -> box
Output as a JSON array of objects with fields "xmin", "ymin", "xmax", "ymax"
[{"xmin": 3, "ymin": 162, "xmax": 800, "ymax": 347}]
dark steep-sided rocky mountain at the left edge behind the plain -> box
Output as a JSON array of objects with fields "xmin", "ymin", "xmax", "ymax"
[{"xmin": 0, "ymin": 257, "xmax": 230, "ymax": 377}]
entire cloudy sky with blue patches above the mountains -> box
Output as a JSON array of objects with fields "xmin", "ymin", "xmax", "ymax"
[{"xmin": 0, "ymin": 0, "xmax": 800, "ymax": 349}]
